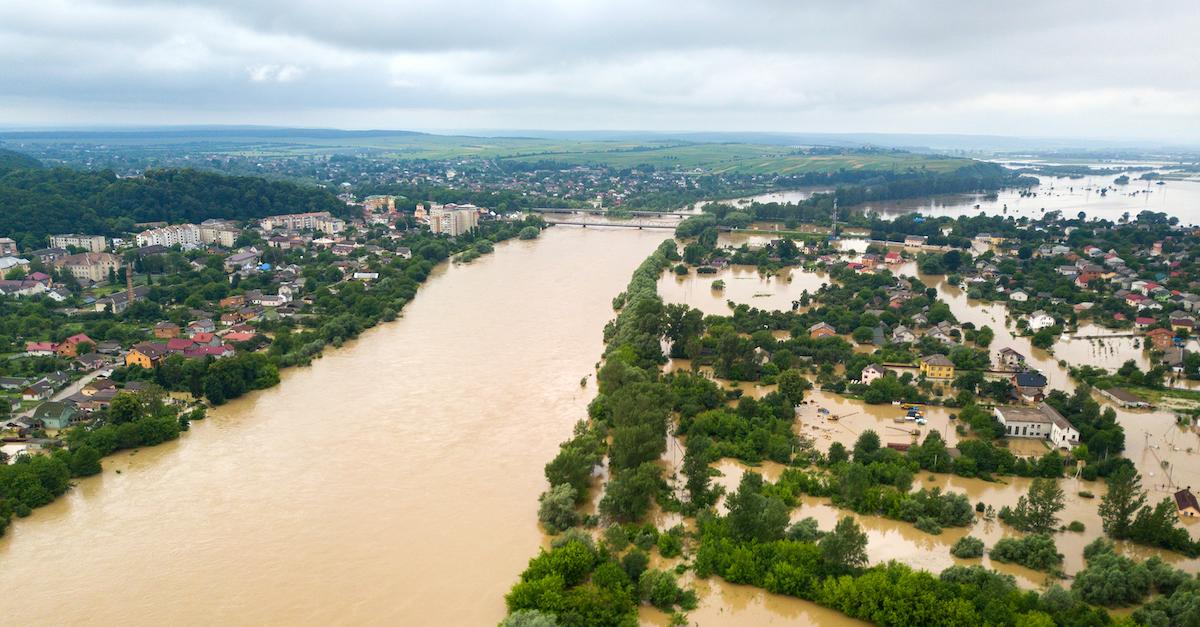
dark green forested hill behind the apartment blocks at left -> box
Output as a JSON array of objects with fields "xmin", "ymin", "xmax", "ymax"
[{"xmin": 0, "ymin": 150, "xmax": 347, "ymax": 249}]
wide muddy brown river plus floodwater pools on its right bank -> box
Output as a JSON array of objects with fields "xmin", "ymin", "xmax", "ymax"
[{"xmin": 0, "ymin": 227, "xmax": 1200, "ymax": 625}]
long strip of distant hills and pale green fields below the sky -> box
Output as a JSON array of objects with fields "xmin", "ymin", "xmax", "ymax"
[{"xmin": 0, "ymin": 130, "xmax": 971, "ymax": 174}]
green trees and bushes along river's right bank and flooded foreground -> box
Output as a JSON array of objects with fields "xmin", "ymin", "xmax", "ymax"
[{"xmin": 502, "ymin": 236, "xmax": 1200, "ymax": 626}]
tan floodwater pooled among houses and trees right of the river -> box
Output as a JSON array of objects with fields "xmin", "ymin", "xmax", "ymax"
[{"xmin": 659, "ymin": 249, "xmax": 1200, "ymax": 589}]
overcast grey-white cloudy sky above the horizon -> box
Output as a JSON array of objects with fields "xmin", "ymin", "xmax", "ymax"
[{"xmin": 0, "ymin": 0, "xmax": 1200, "ymax": 142}]
